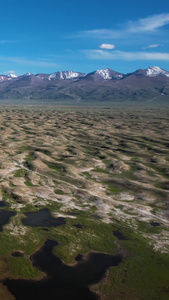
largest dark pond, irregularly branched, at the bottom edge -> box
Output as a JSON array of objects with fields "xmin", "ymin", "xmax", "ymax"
[{"xmin": 3, "ymin": 240, "xmax": 122, "ymax": 300}]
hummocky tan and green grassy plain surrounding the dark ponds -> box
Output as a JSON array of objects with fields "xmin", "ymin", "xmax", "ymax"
[{"xmin": 0, "ymin": 105, "xmax": 169, "ymax": 300}]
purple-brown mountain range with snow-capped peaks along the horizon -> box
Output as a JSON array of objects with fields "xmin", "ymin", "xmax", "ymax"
[{"xmin": 0, "ymin": 67, "xmax": 169, "ymax": 102}]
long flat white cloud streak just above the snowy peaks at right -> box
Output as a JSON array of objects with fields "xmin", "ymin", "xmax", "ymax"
[{"xmin": 83, "ymin": 50, "xmax": 169, "ymax": 61}]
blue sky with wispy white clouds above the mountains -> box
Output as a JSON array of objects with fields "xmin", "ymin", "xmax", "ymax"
[{"xmin": 0, "ymin": 0, "xmax": 169, "ymax": 75}]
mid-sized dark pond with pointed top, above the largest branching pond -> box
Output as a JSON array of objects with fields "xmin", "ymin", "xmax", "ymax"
[{"xmin": 22, "ymin": 208, "xmax": 65, "ymax": 227}]
